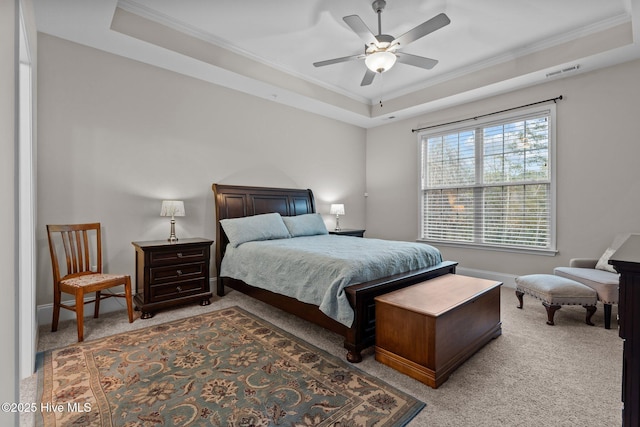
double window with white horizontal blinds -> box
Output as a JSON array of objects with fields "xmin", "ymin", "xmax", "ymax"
[{"xmin": 418, "ymin": 106, "xmax": 555, "ymax": 253}]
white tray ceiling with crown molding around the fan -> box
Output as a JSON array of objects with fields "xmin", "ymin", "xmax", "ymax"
[{"xmin": 34, "ymin": 0, "xmax": 640, "ymax": 127}]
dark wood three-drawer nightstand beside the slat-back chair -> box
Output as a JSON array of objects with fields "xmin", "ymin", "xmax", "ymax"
[{"xmin": 132, "ymin": 238, "xmax": 213, "ymax": 319}]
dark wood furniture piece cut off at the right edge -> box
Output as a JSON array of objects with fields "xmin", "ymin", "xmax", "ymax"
[{"xmin": 609, "ymin": 234, "xmax": 640, "ymax": 426}]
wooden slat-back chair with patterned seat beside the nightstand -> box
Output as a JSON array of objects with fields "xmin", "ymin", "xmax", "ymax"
[{"xmin": 47, "ymin": 223, "xmax": 133, "ymax": 341}]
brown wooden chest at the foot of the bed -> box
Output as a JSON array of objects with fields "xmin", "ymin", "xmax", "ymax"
[{"xmin": 375, "ymin": 274, "xmax": 502, "ymax": 388}]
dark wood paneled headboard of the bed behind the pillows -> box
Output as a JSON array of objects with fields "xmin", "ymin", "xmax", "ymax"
[{"xmin": 211, "ymin": 184, "xmax": 316, "ymax": 275}]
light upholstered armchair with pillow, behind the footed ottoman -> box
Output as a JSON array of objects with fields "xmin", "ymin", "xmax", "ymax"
[{"xmin": 553, "ymin": 233, "xmax": 631, "ymax": 329}]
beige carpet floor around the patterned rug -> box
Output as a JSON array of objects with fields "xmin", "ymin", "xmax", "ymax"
[{"xmin": 21, "ymin": 287, "xmax": 622, "ymax": 426}]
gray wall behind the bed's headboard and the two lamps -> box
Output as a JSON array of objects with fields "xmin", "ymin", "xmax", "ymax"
[{"xmin": 37, "ymin": 34, "xmax": 366, "ymax": 308}]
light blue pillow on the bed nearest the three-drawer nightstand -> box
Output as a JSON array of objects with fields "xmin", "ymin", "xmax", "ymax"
[{"xmin": 220, "ymin": 213, "xmax": 291, "ymax": 248}]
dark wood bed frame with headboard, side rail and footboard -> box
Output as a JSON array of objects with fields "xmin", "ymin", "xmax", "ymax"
[{"xmin": 212, "ymin": 184, "xmax": 457, "ymax": 363}]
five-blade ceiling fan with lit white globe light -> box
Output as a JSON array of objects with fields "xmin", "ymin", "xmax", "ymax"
[{"xmin": 313, "ymin": 0, "xmax": 451, "ymax": 86}]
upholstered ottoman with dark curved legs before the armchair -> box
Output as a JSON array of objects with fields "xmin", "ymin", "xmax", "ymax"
[{"xmin": 516, "ymin": 274, "xmax": 598, "ymax": 326}]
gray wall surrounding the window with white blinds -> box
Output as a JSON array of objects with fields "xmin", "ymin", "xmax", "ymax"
[{"xmin": 366, "ymin": 61, "xmax": 640, "ymax": 275}]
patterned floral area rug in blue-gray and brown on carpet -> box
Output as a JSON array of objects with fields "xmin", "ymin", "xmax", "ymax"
[{"xmin": 36, "ymin": 307, "xmax": 425, "ymax": 426}]
